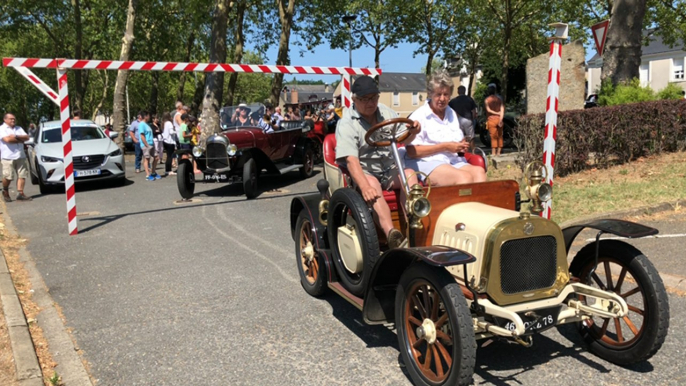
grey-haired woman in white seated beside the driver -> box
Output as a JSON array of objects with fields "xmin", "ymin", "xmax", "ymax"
[{"xmin": 405, "ymin": 71, "xmax": 486, "ymax": 186}]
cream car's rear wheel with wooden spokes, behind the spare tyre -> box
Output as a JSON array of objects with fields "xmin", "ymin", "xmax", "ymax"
[{"xmin": 295, "ymin": 209, "xmax": 326, "ymax": 297}]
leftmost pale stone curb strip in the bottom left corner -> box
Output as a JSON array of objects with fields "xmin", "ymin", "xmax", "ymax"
[{"xmin": 0, "ymin": 246, "xmax": 43, "ymax": 386}]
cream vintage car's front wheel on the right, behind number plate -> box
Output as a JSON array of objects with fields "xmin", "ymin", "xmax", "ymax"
[{"xmin": 570, "ymin": 240, "xmax": 669, "ymax": 365}]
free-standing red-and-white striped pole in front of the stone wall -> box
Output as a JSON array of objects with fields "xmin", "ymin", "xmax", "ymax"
[{"xmin": 541, "ymin": 23, "xmax": 569, "ymax": 219}]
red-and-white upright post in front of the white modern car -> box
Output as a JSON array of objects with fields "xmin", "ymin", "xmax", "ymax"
[{"xmin": 57, "ymin": 67, "xmax": 79, "ymax": 236}]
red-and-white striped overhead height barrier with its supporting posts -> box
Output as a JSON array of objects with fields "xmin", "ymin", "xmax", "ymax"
[{"xmin": 2, "ymin": 58, "xmax": 381, "ymax": 235}]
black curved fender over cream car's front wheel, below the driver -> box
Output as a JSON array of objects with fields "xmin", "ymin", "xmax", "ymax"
[{"xmin": 362, "ymin": 245, "xmax": 476, "ymax": 324}]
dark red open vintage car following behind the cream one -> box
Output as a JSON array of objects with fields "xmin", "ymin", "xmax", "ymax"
[{"xmin": 176, "ymin": 105, "xmax": 315, "ymax": 199}]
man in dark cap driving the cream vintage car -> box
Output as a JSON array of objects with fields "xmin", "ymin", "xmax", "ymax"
[{"xmin": 336, "ymin": 76, "xmax": 421, "ymax": 248}]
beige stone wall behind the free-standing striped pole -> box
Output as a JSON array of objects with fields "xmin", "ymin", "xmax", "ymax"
[{"xmin": 526, "ymin": 41, "xmax": 586, "ymax": 114}]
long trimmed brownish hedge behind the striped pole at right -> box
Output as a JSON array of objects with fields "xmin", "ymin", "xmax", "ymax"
[{"xmin": 514, "ymin": 100, "xmax": 686, "ymax": 176}]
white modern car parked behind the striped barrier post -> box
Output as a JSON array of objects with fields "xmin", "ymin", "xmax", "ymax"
[{"xmin": 26, "ymin": 119, "xmax": 126, "ymax": 194}]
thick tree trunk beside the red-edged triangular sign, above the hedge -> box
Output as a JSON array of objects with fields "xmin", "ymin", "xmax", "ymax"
[{"xmin": 601, "ymin": 0, "xmax": 646, "ymax": 84}]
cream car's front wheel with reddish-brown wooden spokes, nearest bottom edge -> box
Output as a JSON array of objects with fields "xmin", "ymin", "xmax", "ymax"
[{"xmin": 395, "ymin": 263, "xmax": 476, "ymax": 386}]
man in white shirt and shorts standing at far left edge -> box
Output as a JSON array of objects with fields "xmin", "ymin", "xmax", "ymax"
[{"xmin": 0, "ymin": 113, "xmax": 32, "ymax": 202}]
